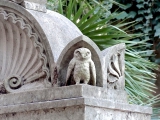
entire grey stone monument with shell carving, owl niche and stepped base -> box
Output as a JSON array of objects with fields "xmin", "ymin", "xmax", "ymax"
[{"xmin": 0, "ymin": 0, "xmax": 152, "ymax": 120}]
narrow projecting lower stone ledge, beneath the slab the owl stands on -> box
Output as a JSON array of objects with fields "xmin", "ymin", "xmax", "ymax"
[{"xmin": 0, "ymin": 98, "xmax": 152, "ymax": 115}]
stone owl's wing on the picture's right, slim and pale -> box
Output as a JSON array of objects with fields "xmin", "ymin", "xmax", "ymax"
[{"xmin": 90, "ymin": 60, "xmax": 96, "ymax": 86}]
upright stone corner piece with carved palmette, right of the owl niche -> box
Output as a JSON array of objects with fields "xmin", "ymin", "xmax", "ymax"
[{"xmin": 102, "ymin": 43, "xmax": 125, "ymax": 90}]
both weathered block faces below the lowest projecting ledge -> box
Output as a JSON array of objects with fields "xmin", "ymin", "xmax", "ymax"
[{"xmin": 0, "ymin": 105, "xmax": 150, "ymax": 120}]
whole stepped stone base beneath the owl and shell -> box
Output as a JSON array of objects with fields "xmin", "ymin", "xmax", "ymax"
[{"xmin": 0, "ymin": 85, "xmax": 152, "ymax": 120}]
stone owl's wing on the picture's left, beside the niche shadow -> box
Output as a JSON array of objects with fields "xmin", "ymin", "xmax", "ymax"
[{"xmin": 66, "ymin": 58, "xmax": 76, "ymax": 84}]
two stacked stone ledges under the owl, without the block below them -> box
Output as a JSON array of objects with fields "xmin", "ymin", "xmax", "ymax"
[{"xmin": 0, "ymin": 85, "xmax": 152, "ymax": 115}]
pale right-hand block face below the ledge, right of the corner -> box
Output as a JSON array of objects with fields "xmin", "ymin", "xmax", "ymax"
[{"xmin": 84, "ymin": 106, "xmax": 151, "ymax": 120}]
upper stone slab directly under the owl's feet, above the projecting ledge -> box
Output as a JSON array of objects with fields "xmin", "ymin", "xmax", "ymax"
[{"xmin": 0, "ymin": 85, "xmax": 127, "ymax": 106}]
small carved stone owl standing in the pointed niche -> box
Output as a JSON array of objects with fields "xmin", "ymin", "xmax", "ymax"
[{"xmin": 66, "ymin": 48, "xmax": 96, "ymax": 86}]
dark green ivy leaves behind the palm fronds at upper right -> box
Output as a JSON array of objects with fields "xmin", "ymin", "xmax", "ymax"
[{"xmin": 112, "ymin": 0, "xmax": 160, "ymax": 120}]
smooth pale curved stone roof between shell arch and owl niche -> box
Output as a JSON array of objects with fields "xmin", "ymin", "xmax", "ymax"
[{"xmin": 27, "ymin": 10, "xmax": 82, "ymax": 62}]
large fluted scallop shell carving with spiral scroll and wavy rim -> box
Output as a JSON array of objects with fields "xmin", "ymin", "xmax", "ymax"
[{"xmin": 0, "ymin": 8, "xmax": 50, "ymax": 92}]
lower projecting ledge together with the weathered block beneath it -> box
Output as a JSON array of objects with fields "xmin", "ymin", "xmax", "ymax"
[{"xmin": 0, "ymin": 93, "xmax": 152, "ymax": 120}]
